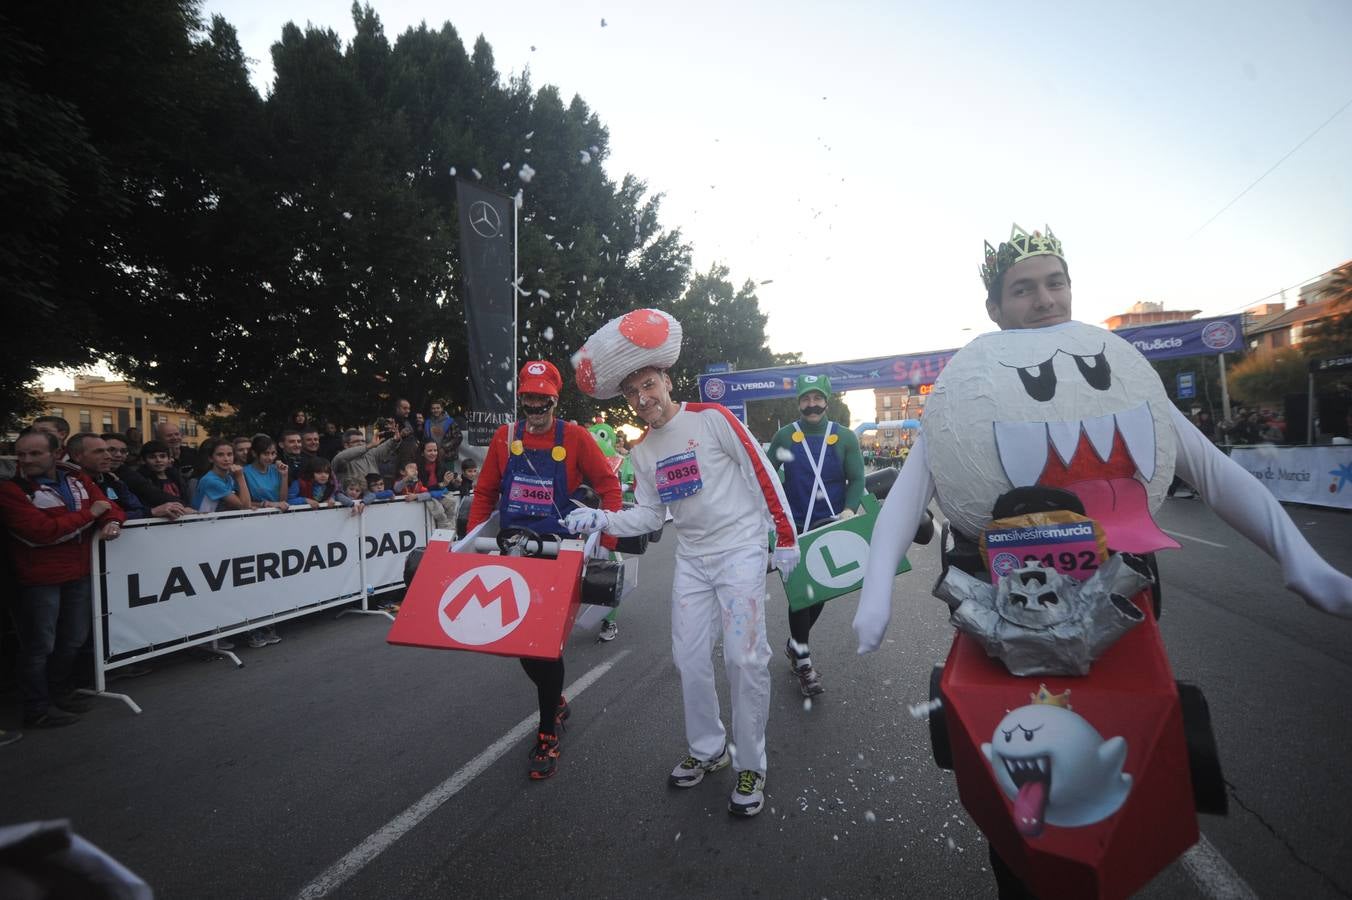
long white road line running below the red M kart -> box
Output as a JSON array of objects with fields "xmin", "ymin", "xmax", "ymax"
[{"xmin": 296, "ymin": 650, "xmax": 629, "ymax": 900}]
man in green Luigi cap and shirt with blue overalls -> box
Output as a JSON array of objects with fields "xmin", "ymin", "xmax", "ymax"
[{"xmin": 768, "ymin": 374, "xmax": 864, "ymax": 697}]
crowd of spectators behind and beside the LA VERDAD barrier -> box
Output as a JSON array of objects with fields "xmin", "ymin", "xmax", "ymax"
[{"xmin": 0, "ymin": 399, "xmax": 477, "ymax": 746}]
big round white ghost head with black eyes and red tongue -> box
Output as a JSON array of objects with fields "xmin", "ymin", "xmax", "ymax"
[{"xmin": 925, "ymin": 322, "xmax": 1178, "ymax": 553}]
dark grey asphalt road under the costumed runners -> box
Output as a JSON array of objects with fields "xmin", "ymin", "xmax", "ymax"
[{"xmin": 0, "ymin": 500, "xmax": 1352, "ymax": 900}]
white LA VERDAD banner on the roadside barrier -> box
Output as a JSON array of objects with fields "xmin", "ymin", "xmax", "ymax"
[{"xmin": 96, "ymin": 501, "xmax": 427, "ymax": 661}]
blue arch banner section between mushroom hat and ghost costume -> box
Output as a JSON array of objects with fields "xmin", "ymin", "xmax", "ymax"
[{"xmin": 699, "ymin": 350, "xmax": 957, "ymax": 405}]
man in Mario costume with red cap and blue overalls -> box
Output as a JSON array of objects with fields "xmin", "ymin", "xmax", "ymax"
[{"xmin": 459, "ymin": 359, "xmax": 621, "ymax": 781}]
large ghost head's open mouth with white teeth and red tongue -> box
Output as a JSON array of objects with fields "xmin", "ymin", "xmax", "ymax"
[{"xmin": 995, "ymin": 403, "xmax": 1179, "ymax": 553}]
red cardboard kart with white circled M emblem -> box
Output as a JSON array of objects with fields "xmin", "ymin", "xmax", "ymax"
[{"xmin": 385, "ymin": 515, "xmax": 623, "ymax": 659}]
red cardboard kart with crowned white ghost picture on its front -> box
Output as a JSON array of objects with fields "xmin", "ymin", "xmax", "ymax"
[{"xmin": 929, "ymin": 491, "xmax": 1226, "ymax": 899}]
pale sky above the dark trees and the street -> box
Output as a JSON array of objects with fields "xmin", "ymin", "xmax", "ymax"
[{"xmin": 47, "ymin": 0, "xmax": 1352, "ymax": 421}]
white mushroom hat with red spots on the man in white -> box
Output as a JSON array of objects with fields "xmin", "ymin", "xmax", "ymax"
[{"xmin": 573, "ymin": 309, "xmax": 681, "ymax": 400}]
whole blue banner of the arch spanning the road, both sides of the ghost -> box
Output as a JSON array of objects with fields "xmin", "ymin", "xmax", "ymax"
[{"xmin": 699, "ymin": 315, "xmax": 1244, "ymax": 405}]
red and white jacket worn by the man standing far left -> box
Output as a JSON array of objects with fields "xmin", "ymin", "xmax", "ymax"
[{"xmin": 0, "ymin": 462, "xmax": 127, "ymax": 585}]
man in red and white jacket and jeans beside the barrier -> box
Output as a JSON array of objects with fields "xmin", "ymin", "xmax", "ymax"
[{"xmin": 0, "ymin": 431, "xmax": 126, "ymax": 728}]
